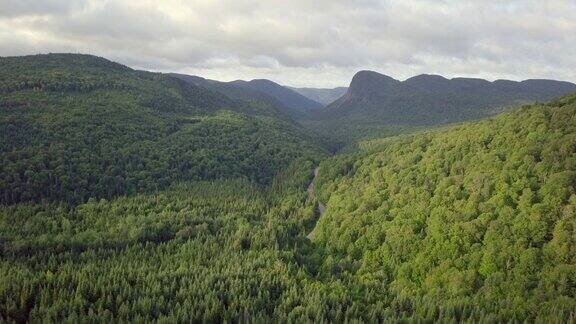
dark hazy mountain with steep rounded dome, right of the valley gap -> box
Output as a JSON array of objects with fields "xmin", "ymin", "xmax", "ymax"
[{"xmin": 288, "ymin": 71, "xmax": 576, "ymax": 150}]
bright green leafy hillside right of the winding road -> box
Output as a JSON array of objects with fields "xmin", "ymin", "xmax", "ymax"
[{"xmin": 315, "ymin": 96, "xmax": 576, "ymax": 321}]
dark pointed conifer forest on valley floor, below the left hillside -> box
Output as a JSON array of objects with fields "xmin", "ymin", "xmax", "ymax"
[{"xmin": 0, "ymin": 160, "xmax": 548, "ymax": 323}]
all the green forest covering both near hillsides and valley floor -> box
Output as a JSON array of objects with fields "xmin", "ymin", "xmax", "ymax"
[{"xmin": 0, "ymin": 54, "xmax": 576, "ymax": 323}]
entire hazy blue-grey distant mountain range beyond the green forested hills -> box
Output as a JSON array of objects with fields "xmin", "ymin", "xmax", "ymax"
[{"xmin": 170, "ymin": 71, "xmax": 576, "ymax": 148}]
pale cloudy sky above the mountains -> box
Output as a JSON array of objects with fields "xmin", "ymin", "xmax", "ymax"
[{"xmin": 0, "ymin": 0, "xmax": 576, "ymax": 87}]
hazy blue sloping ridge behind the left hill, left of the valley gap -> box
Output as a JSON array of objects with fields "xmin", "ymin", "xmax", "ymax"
[{"xmin": 170, "ymin": 73, "xmax": 322, "ymax": 120}]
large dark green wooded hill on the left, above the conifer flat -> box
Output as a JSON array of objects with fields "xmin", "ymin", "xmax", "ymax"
[{"xmin": 0, "ymin": 54, "xmax": 323, "ymax": 204}]
